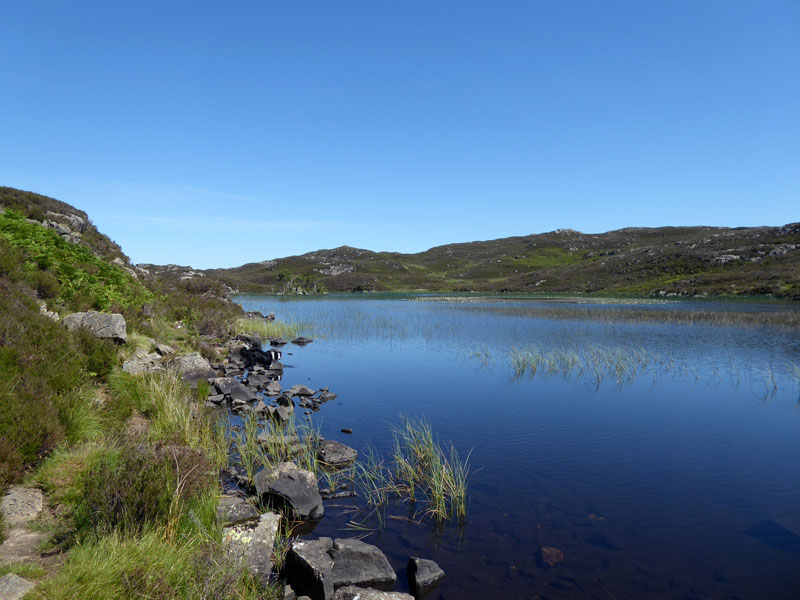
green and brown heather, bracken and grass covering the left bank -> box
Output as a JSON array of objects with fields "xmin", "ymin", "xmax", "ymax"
[{"xmin": 0, "ymin": 188, "xmax": 273, "ymax": 599}]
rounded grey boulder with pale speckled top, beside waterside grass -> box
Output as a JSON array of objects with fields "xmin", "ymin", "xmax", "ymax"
[{"xmin": 253, "ymin": 462, "xmax": 324, "ymax": 521}]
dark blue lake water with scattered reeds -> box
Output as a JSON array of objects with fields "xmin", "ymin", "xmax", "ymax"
[{"xmin": 237, "ymin": 296, "xmax": 800, "ymax": 600}]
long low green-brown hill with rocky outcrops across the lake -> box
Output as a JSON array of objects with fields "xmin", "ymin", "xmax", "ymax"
[{"xmin": 205, "ymin": 223, "xmax": 800, "ymax": 299}]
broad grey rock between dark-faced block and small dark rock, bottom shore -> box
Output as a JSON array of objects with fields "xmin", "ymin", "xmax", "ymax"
[{"xmin": 330, "ymin": 538, "xmax": 397, "ymax": 588}]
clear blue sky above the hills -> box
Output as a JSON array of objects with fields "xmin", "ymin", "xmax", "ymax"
[{"xmin": 0, "ymin": 0, "xmax": 800, "ymax": 268}]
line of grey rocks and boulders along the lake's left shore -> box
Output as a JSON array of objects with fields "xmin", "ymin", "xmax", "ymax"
[{"xmin": 123, "ymin": 314, "xmax": 444, "ymax": 600}]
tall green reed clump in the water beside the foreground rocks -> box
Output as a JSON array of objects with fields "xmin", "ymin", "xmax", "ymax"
[{"xmin": 356, "ymin": 419, "xmax": 470, "ymax": 522}]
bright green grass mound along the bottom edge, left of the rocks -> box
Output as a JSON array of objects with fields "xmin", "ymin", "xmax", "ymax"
[{"xmin": 32, "ymin": 531, "xmax": 272, "ymax": 600}]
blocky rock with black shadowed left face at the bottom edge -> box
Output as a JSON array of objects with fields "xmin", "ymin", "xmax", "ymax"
[{"xmin": 285, "ymin": 538, "xmax": 333, "ymax": 600}]
